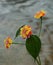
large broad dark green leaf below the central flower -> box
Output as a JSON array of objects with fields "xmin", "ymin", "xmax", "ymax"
[{"xmin": 26, "ymin": 35, "xmax": 41, "ymax": 60}]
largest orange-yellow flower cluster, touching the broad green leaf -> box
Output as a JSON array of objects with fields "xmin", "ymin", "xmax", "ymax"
[{"xmin": 20, "ymin": 25, "xmax": 32, "ymax": 39}]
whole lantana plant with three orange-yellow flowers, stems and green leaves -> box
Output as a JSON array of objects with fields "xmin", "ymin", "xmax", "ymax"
[{"xmin": 4, "ymin": 10, "xmax": 46, "ymax": 65}]
